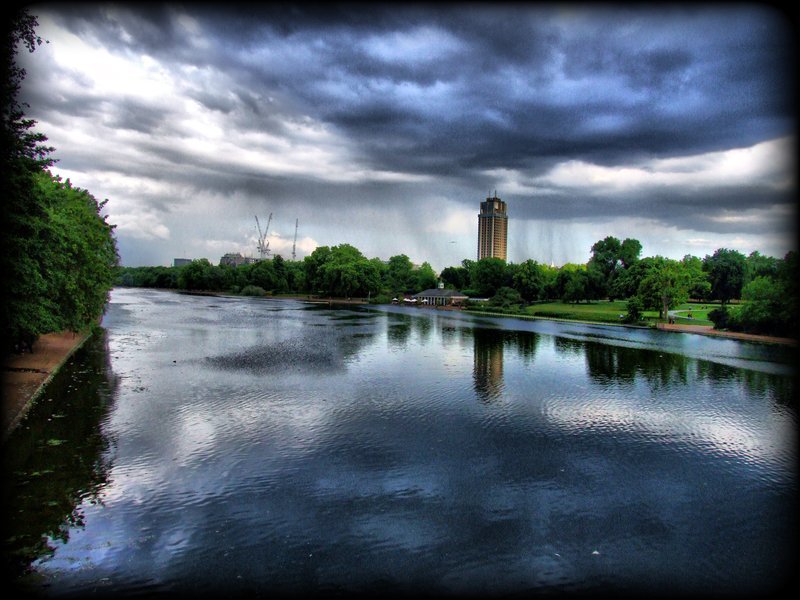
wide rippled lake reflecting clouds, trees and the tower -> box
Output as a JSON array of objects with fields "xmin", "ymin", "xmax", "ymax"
[{"xmin": 4, "ymin": 288, "xmax": 797, "ymax": 596}]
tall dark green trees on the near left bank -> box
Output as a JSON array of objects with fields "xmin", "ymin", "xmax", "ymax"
[{"xmin": 0, "ymin": 10, "xmax": 118, "ymax": 351}]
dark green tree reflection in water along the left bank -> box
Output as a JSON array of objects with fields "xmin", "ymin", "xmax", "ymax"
[{"xmin": 3, "ymin": 329, "xmax": 118, "ymax": 579}]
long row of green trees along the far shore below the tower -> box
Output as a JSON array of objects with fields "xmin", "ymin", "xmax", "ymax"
[{"xmin": 117, "ymin": 236, "xmax": 797, "ymax": 335}]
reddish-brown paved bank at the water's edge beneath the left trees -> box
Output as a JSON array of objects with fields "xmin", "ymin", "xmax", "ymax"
[{"xmin": 2, "ymin": 329, "xmax": 92, "ymax": 440}]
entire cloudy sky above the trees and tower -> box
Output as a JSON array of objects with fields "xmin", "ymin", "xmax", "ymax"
[{"xmin": 19, "ymin": 3, "xmax": 797, "ymax": 271}]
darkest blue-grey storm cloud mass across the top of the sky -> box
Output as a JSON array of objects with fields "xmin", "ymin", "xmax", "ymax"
[{"xmin": 39, "ymin": 4, "xmax": 794, "ymax": 175}]
